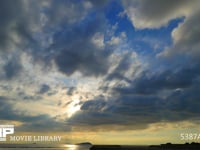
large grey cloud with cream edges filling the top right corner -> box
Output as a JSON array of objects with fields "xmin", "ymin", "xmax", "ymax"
[{"xmin": 122, "ymin": 0, "xmax": 200, "ymax": 59}]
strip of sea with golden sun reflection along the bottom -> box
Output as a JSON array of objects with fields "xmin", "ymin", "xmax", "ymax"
[{"xmin": 0, "ymin": 144, "xmax": 90, "ymax": 150}]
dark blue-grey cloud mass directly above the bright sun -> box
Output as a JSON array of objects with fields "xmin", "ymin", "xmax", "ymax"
[{"xmin": 52, "ymin": 16, "xmax": 111, "ymax": 76}]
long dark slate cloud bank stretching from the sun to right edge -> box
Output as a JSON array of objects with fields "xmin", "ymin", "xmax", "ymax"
[{"xmin": 67, "ymin": 83, "xmax": 200, "ymax": 130}]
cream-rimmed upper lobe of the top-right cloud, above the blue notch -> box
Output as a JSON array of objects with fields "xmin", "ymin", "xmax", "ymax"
[{"xmin": 122, "ymin": 0, "xmax": 199, "ymax": 29}]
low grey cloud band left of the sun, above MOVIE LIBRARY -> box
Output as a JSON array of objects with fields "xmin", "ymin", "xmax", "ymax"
[{"xmin": 0, "ymin": 96, "xmax": 70, "ymax": 132}]
